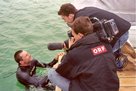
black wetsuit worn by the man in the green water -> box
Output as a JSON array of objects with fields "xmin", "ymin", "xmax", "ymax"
[{"xmin": 16, "ymin": 59, "xmax": 57, "ymax": 88}]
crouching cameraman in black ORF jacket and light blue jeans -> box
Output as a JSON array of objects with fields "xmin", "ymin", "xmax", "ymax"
[{"xmin": 48, "ymin": 17, "xmax": 119, "ymax": 91}]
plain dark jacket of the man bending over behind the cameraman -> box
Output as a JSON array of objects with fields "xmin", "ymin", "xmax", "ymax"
[{"xmin": 75, "ymin": 7, "xmax": 131, "ymax": 45}]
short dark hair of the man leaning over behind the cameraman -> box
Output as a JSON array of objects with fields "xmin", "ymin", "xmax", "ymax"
[{"xmin": 58, "ymin": 3, "xmax": 77, "ymax": 16}]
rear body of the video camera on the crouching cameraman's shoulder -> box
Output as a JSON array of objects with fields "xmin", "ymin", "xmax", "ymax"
[{"xmin": 90, "ymin": 17, "xmax": 119, "ymax": 42}]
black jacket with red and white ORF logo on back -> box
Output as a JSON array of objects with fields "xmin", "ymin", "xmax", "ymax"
[{"xmin": 56, "ymin": 34, "xmax": 119, "ymax": 91}]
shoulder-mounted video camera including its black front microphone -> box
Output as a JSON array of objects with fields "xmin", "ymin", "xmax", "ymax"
[{"xmin": 48, "ymin": 17, "xmax": 119, "ymax": 50}]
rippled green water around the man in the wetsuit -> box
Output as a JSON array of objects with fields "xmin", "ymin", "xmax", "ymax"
[{"xmin": 0, "ymin": 0, "xmax": 72, "ymax": 91}]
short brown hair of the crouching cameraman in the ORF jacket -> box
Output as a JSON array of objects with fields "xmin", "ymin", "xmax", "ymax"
[{"xmin": 71, "ymin": 16, "xmax": 93, "ymax": 35}]
